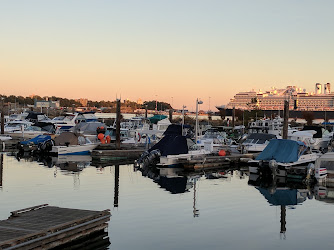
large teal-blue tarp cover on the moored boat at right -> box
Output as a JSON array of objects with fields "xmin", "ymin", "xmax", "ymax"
[{"xmin": 256, "ymin": 139, "xmax": 304, "ymax": 163}]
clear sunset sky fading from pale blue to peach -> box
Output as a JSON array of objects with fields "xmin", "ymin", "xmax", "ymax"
[{"xmin": 0, "ymin": 0, "xmax": 334, "ymax": 110}]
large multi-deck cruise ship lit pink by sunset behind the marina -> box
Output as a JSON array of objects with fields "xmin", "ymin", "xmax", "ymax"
[{"xmin": 222, "ymin": 83, "xmax": 334, "ymax": 111}]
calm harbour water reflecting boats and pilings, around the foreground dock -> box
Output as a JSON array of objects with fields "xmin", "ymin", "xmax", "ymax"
[{"xmin": 0, "ymin": 152, "xmax": 334, "ymax": 250}]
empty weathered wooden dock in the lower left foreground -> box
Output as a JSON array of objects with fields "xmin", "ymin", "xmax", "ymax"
[{"xmin": 0, "ymin": 204, "xmax": 111, "ymax": 249}]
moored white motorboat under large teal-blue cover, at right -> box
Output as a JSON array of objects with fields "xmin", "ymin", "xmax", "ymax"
[{"xmin": 248, "ymin": 139, "xmax": 319, "ymax": 176}]
